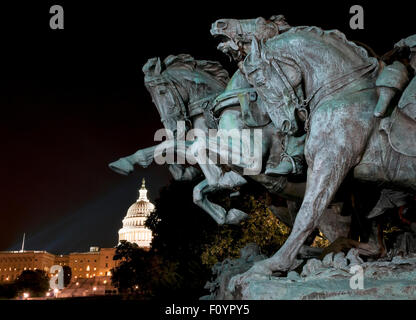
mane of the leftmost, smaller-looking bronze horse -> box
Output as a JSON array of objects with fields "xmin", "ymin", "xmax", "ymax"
[{"xmin": 163, "ymin": 54, "xmax": 230, "ymax": 86}]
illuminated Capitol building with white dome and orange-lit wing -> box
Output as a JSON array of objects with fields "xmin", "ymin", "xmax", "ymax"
[{"xmin": 0, "ymin": 179, "xmax": 155, "ymax": 297}]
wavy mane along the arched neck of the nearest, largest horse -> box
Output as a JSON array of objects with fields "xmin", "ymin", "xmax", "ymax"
[{"xmin": 286, "ymin": 26, "xmax": 377, "ymax": 62}]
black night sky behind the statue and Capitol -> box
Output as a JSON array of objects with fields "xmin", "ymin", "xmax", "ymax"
[{"xmin": 0, "ymin": 1, "xmax": 416, "ymax": 253}]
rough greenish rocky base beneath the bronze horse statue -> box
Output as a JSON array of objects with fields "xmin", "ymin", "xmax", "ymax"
[{"xmin": 201, "ymin": 234, "xmax": 416, "ymax": 300}]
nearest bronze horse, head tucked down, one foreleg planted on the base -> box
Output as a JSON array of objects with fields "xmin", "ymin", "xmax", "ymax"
[{"xmin": 218, "ymin": 27, "xmax": 416, "ymax": 288}]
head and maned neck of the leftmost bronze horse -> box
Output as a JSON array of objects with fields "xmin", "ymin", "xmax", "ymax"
[{"xmin": 143, "ymin": 54, "xmax": 228, "ymax": 132}]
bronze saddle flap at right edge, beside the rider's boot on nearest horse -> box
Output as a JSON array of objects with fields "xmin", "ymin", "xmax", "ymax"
[{"xmin": 382, "ymin": 77, "xmax": 416, "ymax": 157}]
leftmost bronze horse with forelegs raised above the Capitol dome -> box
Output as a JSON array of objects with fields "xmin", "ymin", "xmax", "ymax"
[{"xmin": 109, "ymin": 54, "xmax": 252, "ymax": 224}]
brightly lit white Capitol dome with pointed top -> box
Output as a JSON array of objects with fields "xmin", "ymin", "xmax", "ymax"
[{"xmin": 118, "ymin": 178, "xmax": 155, "ymax": 248}]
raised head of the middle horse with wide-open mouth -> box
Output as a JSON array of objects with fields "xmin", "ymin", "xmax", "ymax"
[{"xmin": 211, "ymin": 15, "xmax": 290, "ymax": 61}]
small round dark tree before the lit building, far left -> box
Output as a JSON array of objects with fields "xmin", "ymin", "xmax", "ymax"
[{"xmin": 15, "ymin": 270, "xmax": 49, "ymax": 297}]
